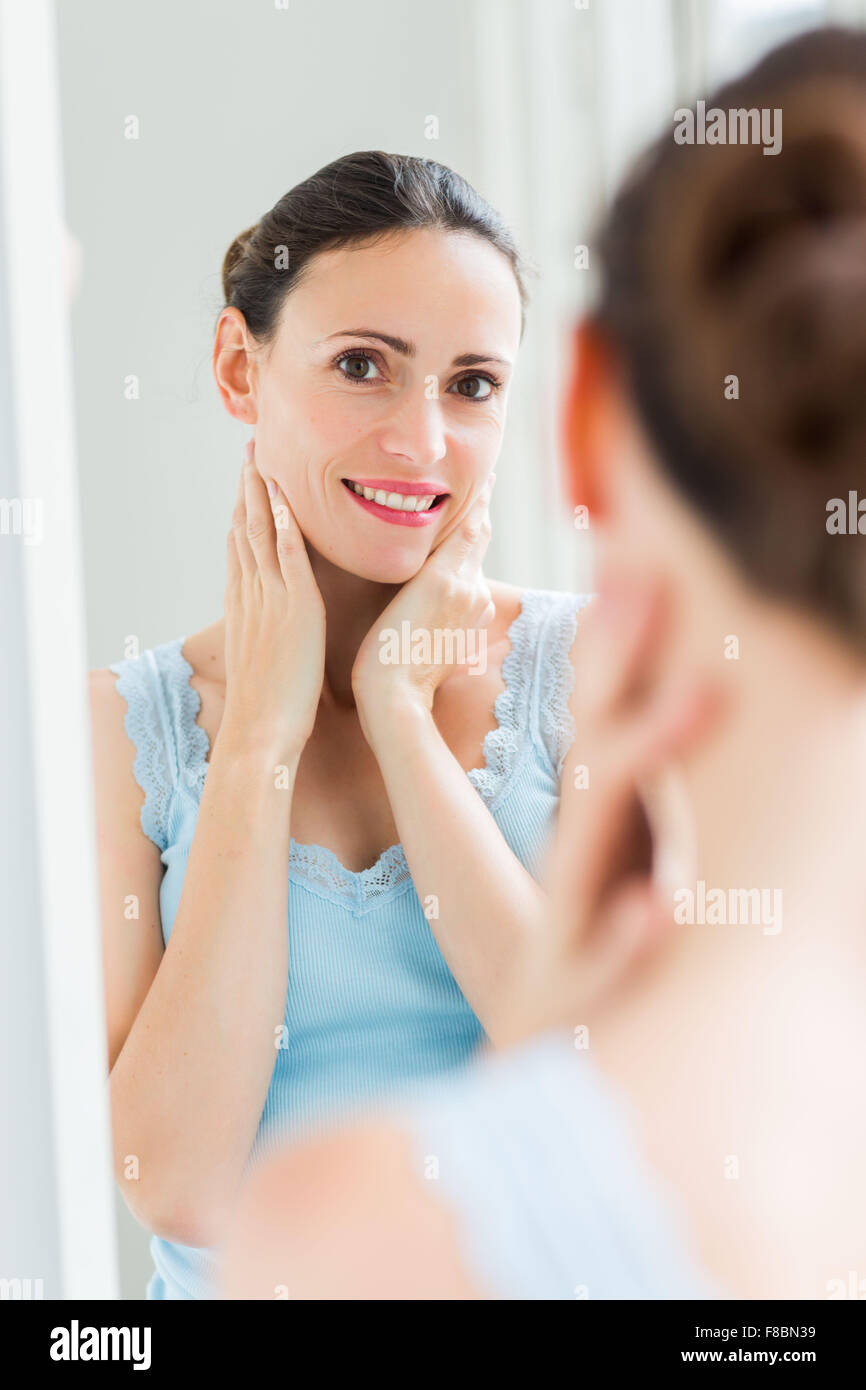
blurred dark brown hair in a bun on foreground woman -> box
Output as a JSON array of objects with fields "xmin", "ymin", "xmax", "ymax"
[{"xmin": 595, "ymin": 28, "xmax": 866, "ymax": 644}]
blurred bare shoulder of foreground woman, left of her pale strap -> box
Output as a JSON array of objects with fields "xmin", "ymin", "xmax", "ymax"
[{"xmin": 224, "ymin": 1122, "xmax": 487, "ymax": 1300}]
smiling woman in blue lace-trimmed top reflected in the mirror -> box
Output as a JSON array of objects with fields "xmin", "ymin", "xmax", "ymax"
[{"xmin": 93, "ymin": 153, "xmax": 594, "ymax": 1298}]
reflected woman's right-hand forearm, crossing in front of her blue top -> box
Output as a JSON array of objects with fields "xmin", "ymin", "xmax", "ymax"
[{"xmin": 367, "ymin": 701, "xmax": 546, "ymax": 1043}]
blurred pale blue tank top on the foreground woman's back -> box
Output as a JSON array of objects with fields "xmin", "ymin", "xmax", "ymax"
[{"xmin": 391, "ymin": 1029, "xmax": 731, "ymax": 1300}]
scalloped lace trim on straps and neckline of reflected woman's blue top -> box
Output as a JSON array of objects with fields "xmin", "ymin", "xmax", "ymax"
[{"xmin": 110, "ymin": 589, "xmax": 588, "ymax": 905}]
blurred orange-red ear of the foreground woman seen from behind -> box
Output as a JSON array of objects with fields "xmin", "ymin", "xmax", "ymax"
[{"xmin": 562, "ymin": 320, "xmax": 616, "ymax": 518}]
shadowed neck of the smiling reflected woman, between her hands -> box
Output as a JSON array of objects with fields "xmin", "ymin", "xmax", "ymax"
[{"xmin": 307, "ymin": 542, "xmax": 400, "ymax": 706}]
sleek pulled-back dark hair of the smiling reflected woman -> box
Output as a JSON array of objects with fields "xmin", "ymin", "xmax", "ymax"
[{"xmin": 222, "ymin": 150, "xmax": 527, "ymax": 345}]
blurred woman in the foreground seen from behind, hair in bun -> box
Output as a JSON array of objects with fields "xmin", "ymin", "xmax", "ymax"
[{"xmin": 224, "ymin": 31, "xmax": 866, "ymax": 1298}]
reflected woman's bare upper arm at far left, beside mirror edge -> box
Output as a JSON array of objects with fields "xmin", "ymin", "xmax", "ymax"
[{"xmin": 90, "ymin": 670, "xmax": 164, "ymax": 1070}]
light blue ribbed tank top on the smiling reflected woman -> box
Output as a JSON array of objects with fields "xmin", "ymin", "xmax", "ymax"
[{"xmin": 110, "ymin": 589, "xmax": 591, "ymax": 1300}]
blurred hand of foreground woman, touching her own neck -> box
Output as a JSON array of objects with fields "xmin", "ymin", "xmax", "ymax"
[{"xmin": 494, "ymin": 569, "xmax": 721, "ymax": 1044}]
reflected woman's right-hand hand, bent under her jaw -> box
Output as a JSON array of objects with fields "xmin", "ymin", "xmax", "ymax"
[{"xmin": 352, "ymin": 475, "xmax": 496, "ymax": 739}]
